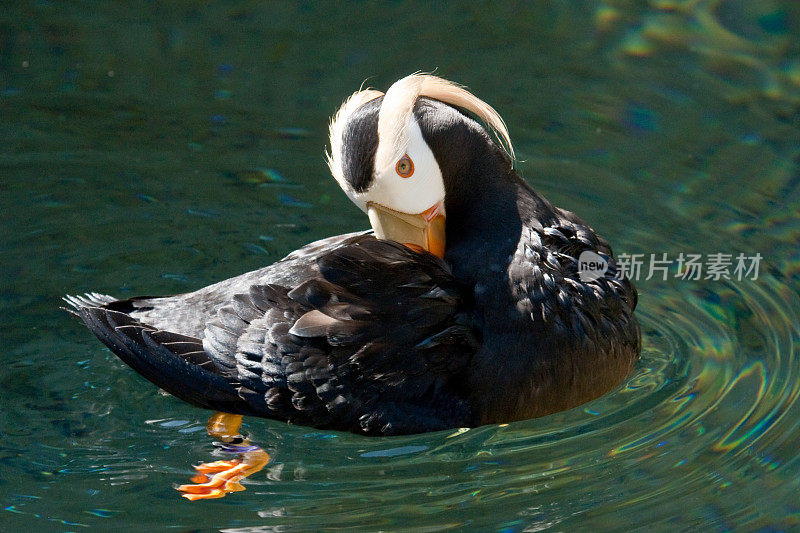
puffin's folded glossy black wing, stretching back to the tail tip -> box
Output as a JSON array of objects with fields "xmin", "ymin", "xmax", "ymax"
[{"xmin": 65, "ymin": 235, "xmax": 478, "ymax": 434}]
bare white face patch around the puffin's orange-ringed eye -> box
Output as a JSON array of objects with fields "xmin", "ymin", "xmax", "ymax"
[{"xmin": 348, "ymin": 118, "xmax": 444, "ymax": 215}]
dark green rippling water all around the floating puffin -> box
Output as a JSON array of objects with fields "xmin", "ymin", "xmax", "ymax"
[{"xmin": 0, "ymin": 0, "xmax": 800, "ymax": 531}]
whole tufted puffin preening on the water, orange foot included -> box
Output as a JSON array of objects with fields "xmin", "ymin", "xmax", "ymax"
[{"xmin": 65, "ymin": 74, "xmax": 641, "ymax": 499}]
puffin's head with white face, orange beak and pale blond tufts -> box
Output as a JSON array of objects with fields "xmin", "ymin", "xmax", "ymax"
[{"xmin": 328, "ymin": 74, "xmax": 514, "ymax": 257}]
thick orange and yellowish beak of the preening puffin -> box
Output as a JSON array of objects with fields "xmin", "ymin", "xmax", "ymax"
[{"xmin": 367, "ymin": 202, "xmax": 445, "ymax": 258}]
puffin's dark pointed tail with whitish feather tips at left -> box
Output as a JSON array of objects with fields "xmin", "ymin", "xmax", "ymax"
[{"xmin": 64, "ymin": 293, "xmax": 248, "ymax": 414}]
